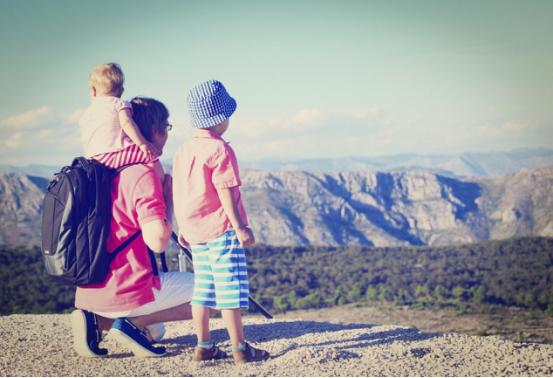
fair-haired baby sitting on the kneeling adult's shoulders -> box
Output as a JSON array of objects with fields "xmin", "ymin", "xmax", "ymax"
[{"xmin": 79, "ymin": 63, "xmax": 163, "ymax": 170}]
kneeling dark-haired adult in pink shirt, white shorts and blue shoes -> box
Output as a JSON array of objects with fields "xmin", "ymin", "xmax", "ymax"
[{"xmin": 71, "ymin": 98, "xmax": 194, "ymax": 357}]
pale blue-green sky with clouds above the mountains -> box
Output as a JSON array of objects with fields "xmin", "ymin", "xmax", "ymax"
[{"xmin": 0, "ymin": 0, "xmax": 553, "ymax": 165}]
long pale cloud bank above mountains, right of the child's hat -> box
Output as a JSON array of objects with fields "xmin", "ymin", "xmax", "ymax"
[{"xmin": 228, "ymin": 107, "xmax": 553, "ymax": 160}]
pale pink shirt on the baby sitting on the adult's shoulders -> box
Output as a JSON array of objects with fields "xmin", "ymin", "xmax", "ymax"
[{"xmin": 79, "ymin": 96, "xmax": 133, "ymax": 158}]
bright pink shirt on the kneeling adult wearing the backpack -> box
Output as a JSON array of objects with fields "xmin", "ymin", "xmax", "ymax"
[{"xmin": 75, "ymin": 164, "xmax": 165, "ymax": 312}]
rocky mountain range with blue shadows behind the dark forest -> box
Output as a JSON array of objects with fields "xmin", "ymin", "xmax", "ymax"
[{"xmin": 0, "ymin": 166, "xmax": 553, "ymax": 246}]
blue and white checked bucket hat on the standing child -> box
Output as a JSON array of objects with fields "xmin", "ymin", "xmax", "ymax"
[{"xmin": 188, "ymin": 80, "xmax": 236, "ymax": 129}]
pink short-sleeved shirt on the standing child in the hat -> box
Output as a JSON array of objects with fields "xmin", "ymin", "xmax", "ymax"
[{"xmin": 173, "ymin": 129, "xmax": 248, "ymax": 243}]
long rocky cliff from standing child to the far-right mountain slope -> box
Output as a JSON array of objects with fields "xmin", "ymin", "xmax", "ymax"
[{"xmin": 243, "ymin": 171, "xmax": 482, "ymax": 246}]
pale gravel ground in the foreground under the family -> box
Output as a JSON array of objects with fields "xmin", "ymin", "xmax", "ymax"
[{"xmin": 0, "ymin": 315, "xmax": 553, "ymax": 376}]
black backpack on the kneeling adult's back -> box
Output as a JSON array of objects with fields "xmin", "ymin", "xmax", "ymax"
[{"xmin": 42, "ymin": 157, "xmax": 140, "ymax": 286}]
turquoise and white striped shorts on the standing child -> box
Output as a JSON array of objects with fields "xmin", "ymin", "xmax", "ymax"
[{"xmin": 191, "ymin": 230, "xmax": 250, "ymax": 310}]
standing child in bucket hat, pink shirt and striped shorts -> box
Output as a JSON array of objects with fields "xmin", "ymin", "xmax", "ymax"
[{"xmin": 173, "ymin": 80, "xmax": 269, "ymax": 363}]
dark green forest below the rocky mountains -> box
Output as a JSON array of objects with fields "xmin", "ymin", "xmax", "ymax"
[{"xmin": 0, "ymin": 238, "xmax": 553, "ymax": 315}]
